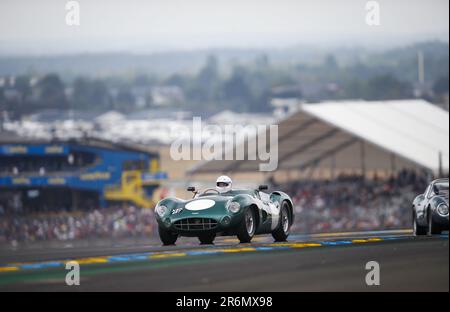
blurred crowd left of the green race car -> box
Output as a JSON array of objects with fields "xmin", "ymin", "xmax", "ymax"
[{"xmin": 0, "ymin": 205, "xmax": 155, "ymax": 243}]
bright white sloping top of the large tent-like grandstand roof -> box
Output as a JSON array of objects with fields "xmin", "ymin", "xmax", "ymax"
[{"xmin": 303, "ymin": 100, "xmax": 449, "ymax": 171}]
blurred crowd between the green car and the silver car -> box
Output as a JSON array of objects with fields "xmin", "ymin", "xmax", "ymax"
[{"xmin": 285, "ymin": 171, "xmax": 429, "ymax": 233}]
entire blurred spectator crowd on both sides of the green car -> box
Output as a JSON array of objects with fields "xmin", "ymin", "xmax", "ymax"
[{"xmin": 0, "ymin": 171, "xmax": 438, "ymax": 243}]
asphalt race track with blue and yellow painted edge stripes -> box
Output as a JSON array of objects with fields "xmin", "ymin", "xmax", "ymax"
[{"xmin": 0, "ymin": 231, "xmax": 449, "ymax": 292}]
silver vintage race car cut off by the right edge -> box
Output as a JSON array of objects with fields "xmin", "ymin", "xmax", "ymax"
[{"xmin": 412, "ymin": 179, "xmax": 449, "ymax": 235}]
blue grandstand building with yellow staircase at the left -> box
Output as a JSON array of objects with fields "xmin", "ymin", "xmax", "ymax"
[{"xmin": 0, "ymin": 135, "xmax": 167, "ymax": 213}]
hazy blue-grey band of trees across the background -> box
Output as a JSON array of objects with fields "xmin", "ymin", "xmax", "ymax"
[{"xmin": 0, "ymin": 44, "xmax": 449, "ymax": 116}]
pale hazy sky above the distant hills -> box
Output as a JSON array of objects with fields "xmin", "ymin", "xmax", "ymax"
[{"xmin": 0, "ymin": 0, "xmax": 449, "ymax": 54}]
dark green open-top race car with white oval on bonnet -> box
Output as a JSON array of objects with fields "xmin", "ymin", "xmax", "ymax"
[{"xmin": 155, "ymin": 186, "xmax": 294, "ymax": 245}]
